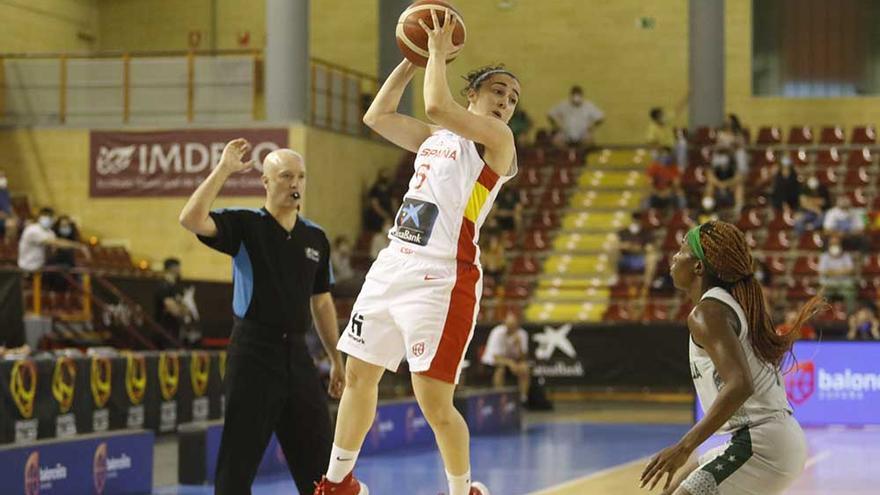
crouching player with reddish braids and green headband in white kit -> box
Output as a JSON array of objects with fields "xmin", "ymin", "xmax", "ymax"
[{"xmin": 641, "ymin": 221, "xmax": 824, "ymax": 495}]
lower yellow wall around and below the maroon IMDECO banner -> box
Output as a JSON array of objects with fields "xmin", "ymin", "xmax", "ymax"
[{"xmin": 0, "ymin": 126, "xmax": 400, "ymax": 280}]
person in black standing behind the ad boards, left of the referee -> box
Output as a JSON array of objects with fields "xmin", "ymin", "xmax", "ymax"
[{"xmin": 153, "ymin": 258, "xmax": 200, "ymax": 348}]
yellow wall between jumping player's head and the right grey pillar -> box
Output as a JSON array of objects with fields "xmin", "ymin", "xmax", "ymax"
[{"xmin": 410, "ymin": 0, "xmax": 692, "ymax": 143}]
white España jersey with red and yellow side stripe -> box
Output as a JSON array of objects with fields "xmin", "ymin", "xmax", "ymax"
[{"xmin": 388, "ymin": 129, "xmax": 516, "ymax": 264}]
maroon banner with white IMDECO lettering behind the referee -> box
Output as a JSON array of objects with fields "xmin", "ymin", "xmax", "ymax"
[{"xmin": 89, "ymin": 128, "xmax": 288, "ymax": 198}]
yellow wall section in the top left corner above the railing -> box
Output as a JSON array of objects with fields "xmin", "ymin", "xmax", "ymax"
[{"xmin": 0, "ymin": 0, "xmax": 98, "ymax": 53}]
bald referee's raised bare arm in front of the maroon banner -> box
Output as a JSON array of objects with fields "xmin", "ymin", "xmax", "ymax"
[{"xmin": 179, "ymin": 138, "xmax": 254, "ymax": 237}]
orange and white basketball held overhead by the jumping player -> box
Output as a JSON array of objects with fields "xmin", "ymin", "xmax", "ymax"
[{"xmin": 396, "ymin": 0, "xmax": 467, "ymax": 67}]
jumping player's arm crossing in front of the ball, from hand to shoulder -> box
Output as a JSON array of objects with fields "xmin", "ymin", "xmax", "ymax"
[{"xmin": 419, "ymin": 10, "xmax": 516, "ymax": 175}]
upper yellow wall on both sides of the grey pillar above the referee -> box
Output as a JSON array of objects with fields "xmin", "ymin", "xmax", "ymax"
[{"xmin": 98, "ymin": 0, "xmax": 379, "ymax": 75}]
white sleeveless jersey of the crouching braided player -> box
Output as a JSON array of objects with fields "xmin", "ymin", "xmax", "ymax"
[{"xmin": 689, "ymin": 287, "xmax": 792, "ymax": 433}]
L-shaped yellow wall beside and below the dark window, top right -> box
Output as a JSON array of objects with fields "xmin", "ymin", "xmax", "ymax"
[{"xmin": 724, "ymin": 1, "xmax": 880, "ymax": 135}]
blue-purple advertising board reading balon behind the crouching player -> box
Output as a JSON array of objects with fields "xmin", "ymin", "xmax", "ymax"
[{"xmin": 695, "ymin": 341, "xmax": 880, "ymax": 426}]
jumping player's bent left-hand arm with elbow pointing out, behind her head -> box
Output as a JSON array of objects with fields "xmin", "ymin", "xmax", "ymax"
[{"xmin": 364, "ymin": 59, "xmax": 433, "ymax": 153}]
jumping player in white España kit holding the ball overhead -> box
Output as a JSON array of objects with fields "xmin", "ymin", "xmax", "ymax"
[{"xmin": 315, "ymin": 8, "xmax": 520, "ymax": 495}]
